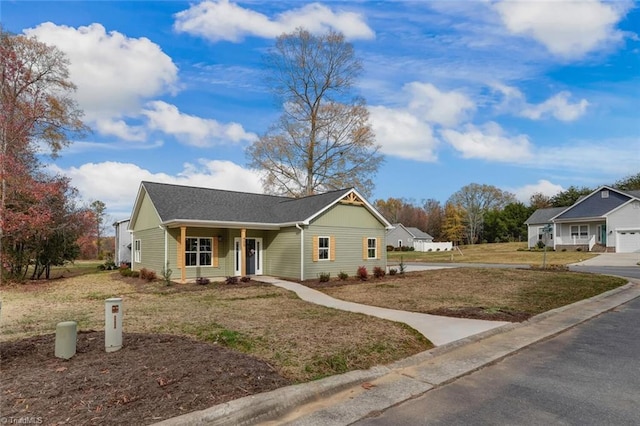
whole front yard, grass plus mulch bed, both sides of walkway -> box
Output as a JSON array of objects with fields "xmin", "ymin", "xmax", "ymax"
[{"xmin": 0, "ymin": 268, "xmax": 625, "ymax": 424}]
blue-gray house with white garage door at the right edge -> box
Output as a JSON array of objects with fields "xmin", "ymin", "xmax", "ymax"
[{"xmin": 525, "ymin": 186, "xmax": 640, "ymax": 253}]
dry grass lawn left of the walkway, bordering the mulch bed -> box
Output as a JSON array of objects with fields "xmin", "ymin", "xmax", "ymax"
[{"xmin": 0, "ymin": 272, "xmax": 432, "ymax": 381}]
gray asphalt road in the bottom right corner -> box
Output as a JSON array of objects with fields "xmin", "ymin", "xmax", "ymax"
[{"xmin": 355, "ymin": 298, "xmax": 640, "ymax": 426}]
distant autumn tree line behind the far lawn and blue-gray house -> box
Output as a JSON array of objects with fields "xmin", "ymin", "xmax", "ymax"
[{"xmin": 374, "ymin": 173, "xmax": 640, "ymax": 244}]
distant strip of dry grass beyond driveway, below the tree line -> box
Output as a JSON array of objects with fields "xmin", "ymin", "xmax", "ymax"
[{"xmin": 387, "ymin": 243, "xmax": 596, "ymax": 266}]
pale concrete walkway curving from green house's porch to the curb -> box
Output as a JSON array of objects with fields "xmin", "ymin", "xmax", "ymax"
[{"xmin": 260, "ymin": 276, "xmax": 510, "ymax": 346}]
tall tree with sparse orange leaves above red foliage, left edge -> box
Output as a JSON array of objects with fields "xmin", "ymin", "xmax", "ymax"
[{"xmin": 0, "ymin": 26, "xmax": 86, "ymax": 284}]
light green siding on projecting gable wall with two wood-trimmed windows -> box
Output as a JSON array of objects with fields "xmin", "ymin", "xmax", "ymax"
[{"xmin": 304, "ymin": 204, "xmax": 387, "ymax": 279}]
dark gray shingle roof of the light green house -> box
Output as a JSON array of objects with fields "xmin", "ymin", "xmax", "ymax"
[{"xmin": 142, "ymin": 182, "xmax": 351, "ymax": 224}]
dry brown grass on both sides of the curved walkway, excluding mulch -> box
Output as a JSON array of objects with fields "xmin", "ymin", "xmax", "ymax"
[{"xmin": 0, "ymin": 268, "xmax": 625, "ymax": 381}]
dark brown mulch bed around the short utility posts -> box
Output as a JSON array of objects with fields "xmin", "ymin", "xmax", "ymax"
[{"xmin": 0, "ymin": 331, "xmax": 290, "ymax": 425}]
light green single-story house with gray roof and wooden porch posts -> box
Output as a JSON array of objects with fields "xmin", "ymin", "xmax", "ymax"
[{"xmin": 129, "ymin": 182, "xmax": 391, "ymax": 282}]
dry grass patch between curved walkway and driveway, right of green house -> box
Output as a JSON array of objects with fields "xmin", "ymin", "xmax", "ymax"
[{"xmin": 322, "ymin": 268, "xmax": 626, "ymax": 314}]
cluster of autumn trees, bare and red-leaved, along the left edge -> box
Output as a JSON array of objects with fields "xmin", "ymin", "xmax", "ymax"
[{"xmin": 0, "ymin": 26, "xmax": 105, "ymax": 284}]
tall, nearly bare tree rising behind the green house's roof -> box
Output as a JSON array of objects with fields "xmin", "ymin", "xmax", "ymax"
[{"xmin": 247, "ymin": 29, "xmax": 383, "ymax": 197}]
